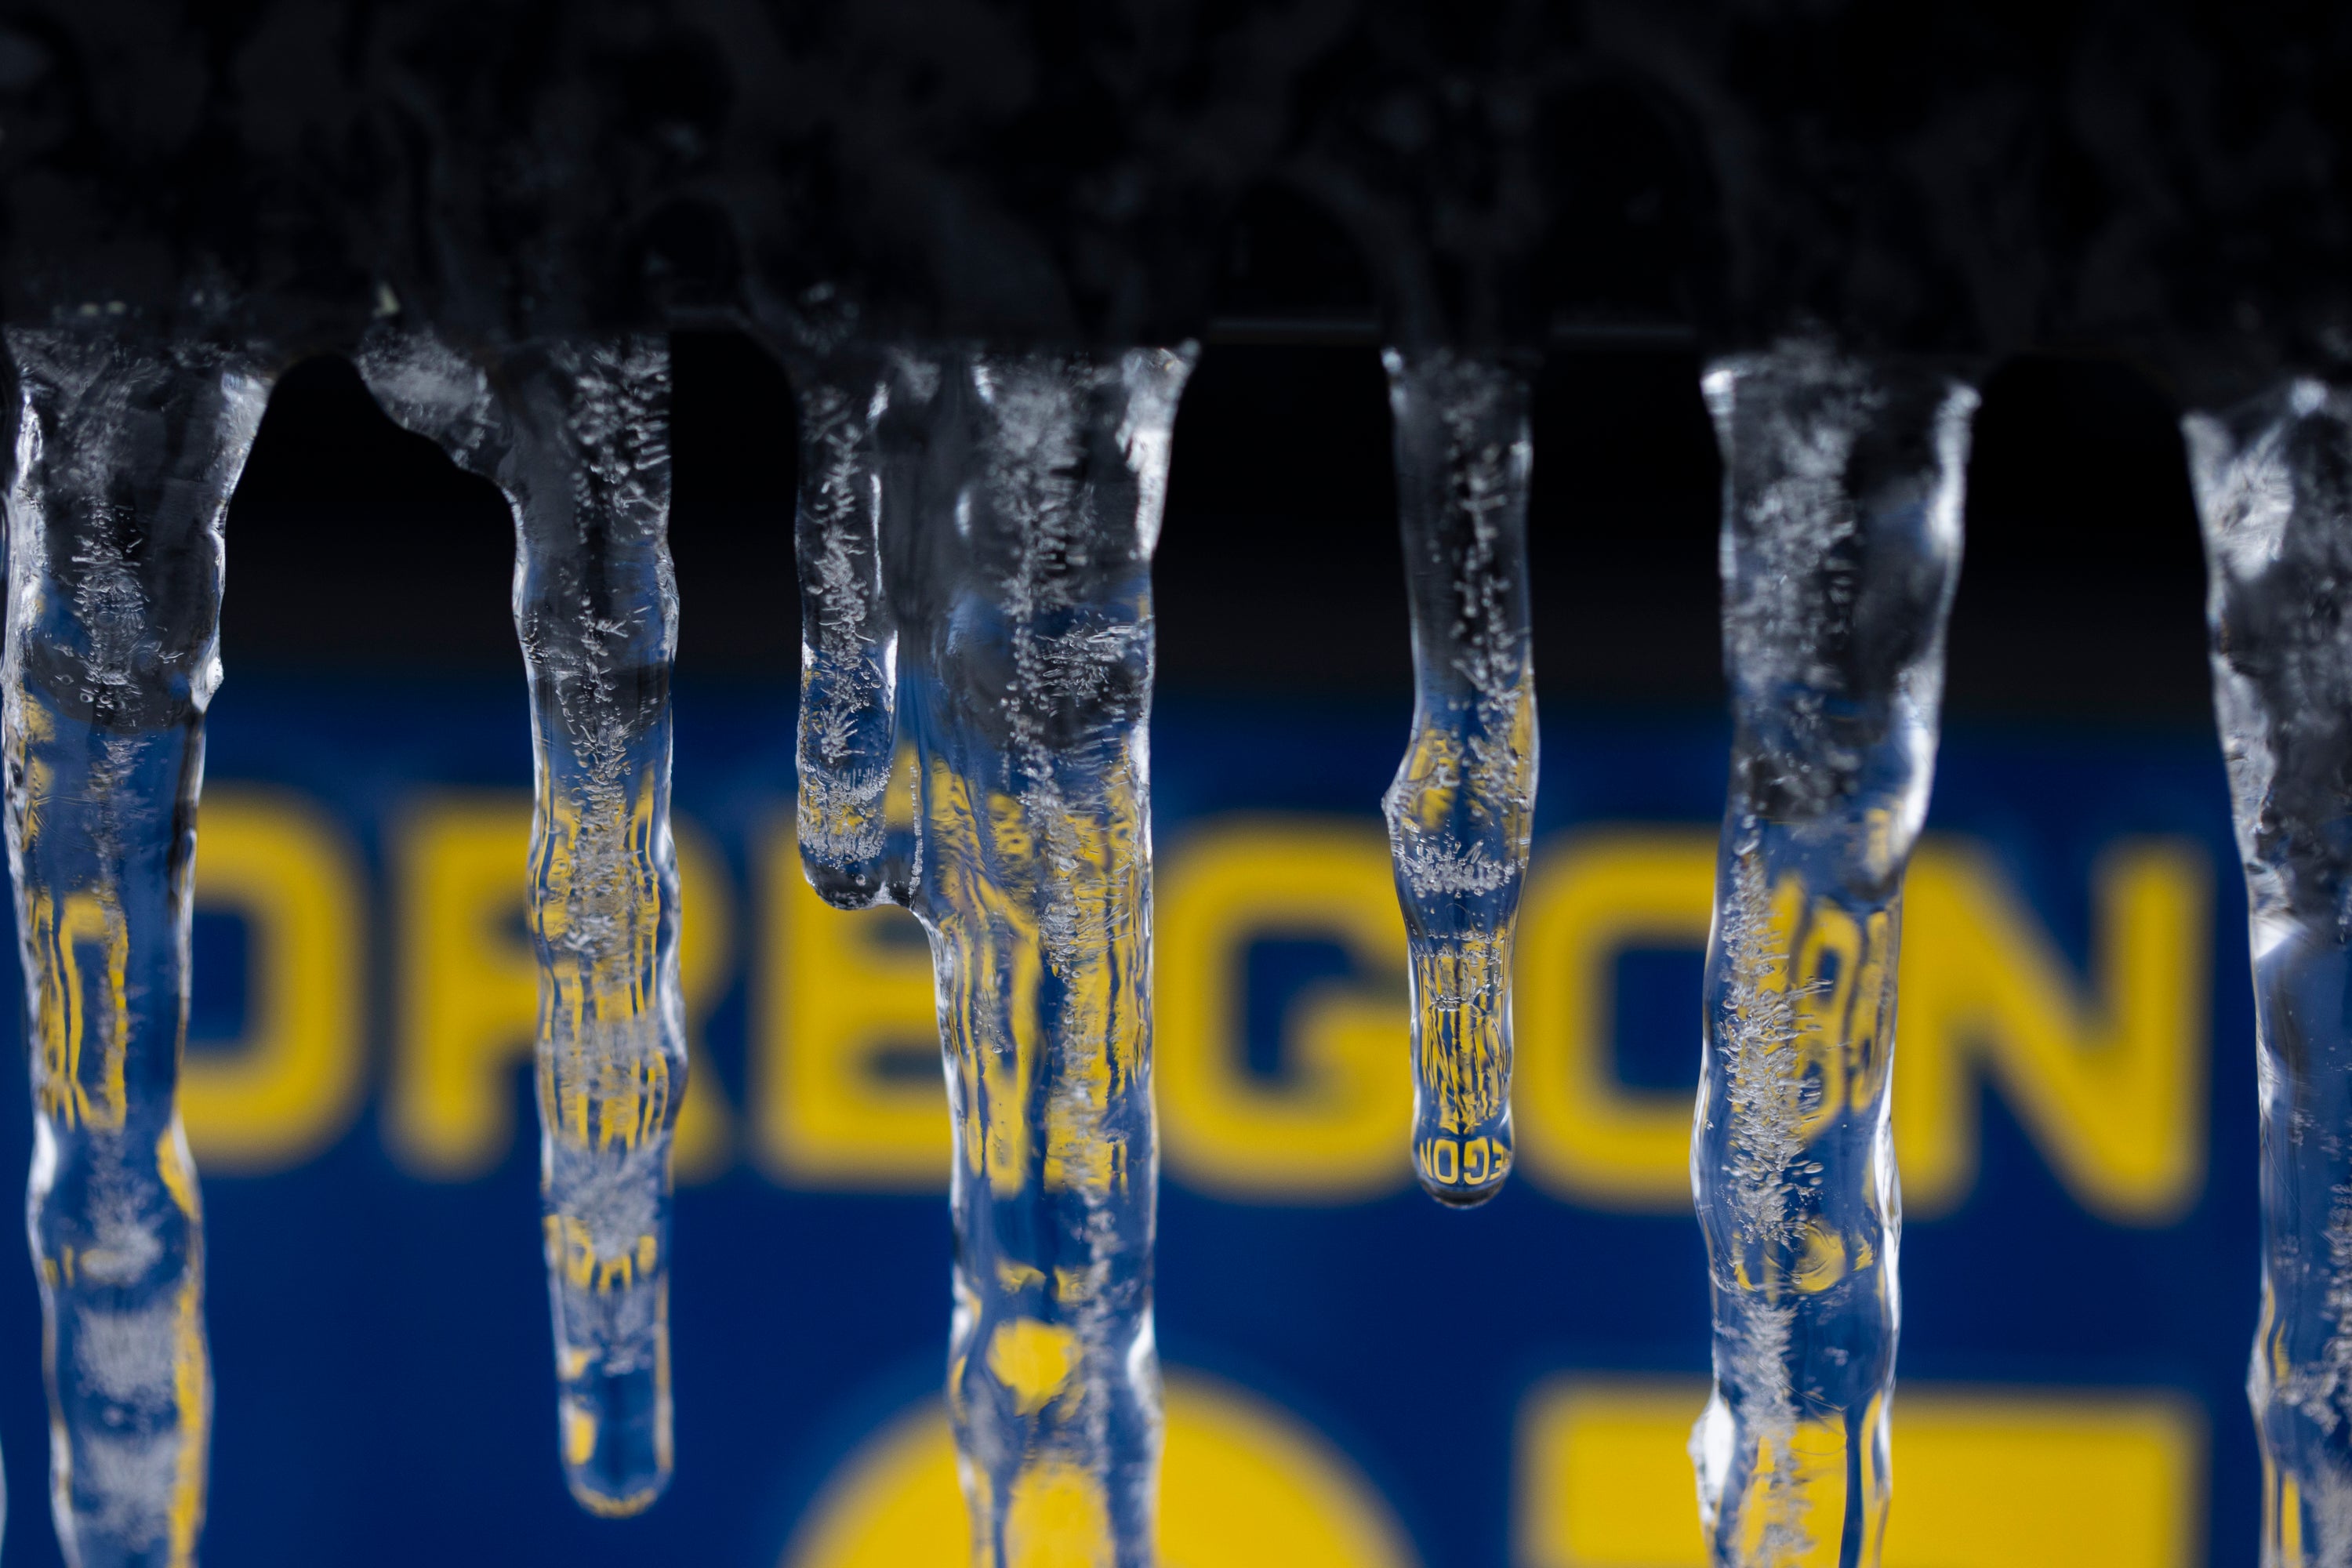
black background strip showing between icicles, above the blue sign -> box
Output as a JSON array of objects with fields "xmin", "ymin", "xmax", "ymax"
[{"xmin": 221, "ymin": 334, "xmax": 2211, "ymax": 727}]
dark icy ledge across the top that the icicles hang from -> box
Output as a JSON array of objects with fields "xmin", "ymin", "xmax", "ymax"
[{"xmin": 0, "ymin": 0, "xmax": 2352, "ymax": 400}]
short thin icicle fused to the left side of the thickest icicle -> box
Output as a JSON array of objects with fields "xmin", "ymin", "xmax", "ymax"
[{"xmin": 795, "ymin": 353, "xmax": 906, "ymax": 909}]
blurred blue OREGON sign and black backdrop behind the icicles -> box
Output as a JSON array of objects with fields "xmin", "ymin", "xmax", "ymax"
[{"xmin": 0, "ymin": 332, "xmax": 2258, "ymax": 1568}]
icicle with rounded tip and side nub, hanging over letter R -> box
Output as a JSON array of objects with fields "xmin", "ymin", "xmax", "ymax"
[{"xmin": 360, "ymin": 336, "xmax": 687, "ymax": 1516}]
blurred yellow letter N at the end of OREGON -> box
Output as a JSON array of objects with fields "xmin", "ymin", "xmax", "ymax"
[{"xmin": 1896, "ymin": 839, "xmax": 2211, "ymax": 1225}]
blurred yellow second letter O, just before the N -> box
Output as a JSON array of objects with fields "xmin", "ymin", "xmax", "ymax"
[{"xmin": 1515, "ymin": 827, "xmax": 1715, "ymax": 1210}]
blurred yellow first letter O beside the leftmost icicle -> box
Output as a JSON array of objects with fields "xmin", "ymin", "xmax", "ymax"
[{"xmin": 179, "ymin": 785, "xmax": 367, "ymax": 1173}]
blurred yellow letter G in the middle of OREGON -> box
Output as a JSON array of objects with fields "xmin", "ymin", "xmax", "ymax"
[{"xmin": 1155, "ymin": 818, "xmax": 1402, "ymax": 1203}]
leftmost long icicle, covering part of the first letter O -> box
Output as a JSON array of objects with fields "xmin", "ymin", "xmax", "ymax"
[{"xmin": 0, "ymin": 329, "xmax": 268, "ymax": 1566}]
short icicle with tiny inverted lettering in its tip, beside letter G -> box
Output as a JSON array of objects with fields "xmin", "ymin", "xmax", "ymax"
[{"xmin": 1383, "ymin": 350, "xmax": 1536, "ymax": 1206}]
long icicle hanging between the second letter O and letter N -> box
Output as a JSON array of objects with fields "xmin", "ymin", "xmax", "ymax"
[{"xmin": 1691, "ymin": 343, "xmax": 1976, "ymax": 1568}]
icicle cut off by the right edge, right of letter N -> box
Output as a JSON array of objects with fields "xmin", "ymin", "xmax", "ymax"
[{"xmin": 2183, "ymin": 381, "xmax": 2352, "ymax": 1568}]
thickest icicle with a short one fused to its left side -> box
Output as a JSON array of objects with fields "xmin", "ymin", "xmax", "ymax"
[{"xmin": 800, "ymin": 350, "xmax": 1192, "ymax": 1568}]
